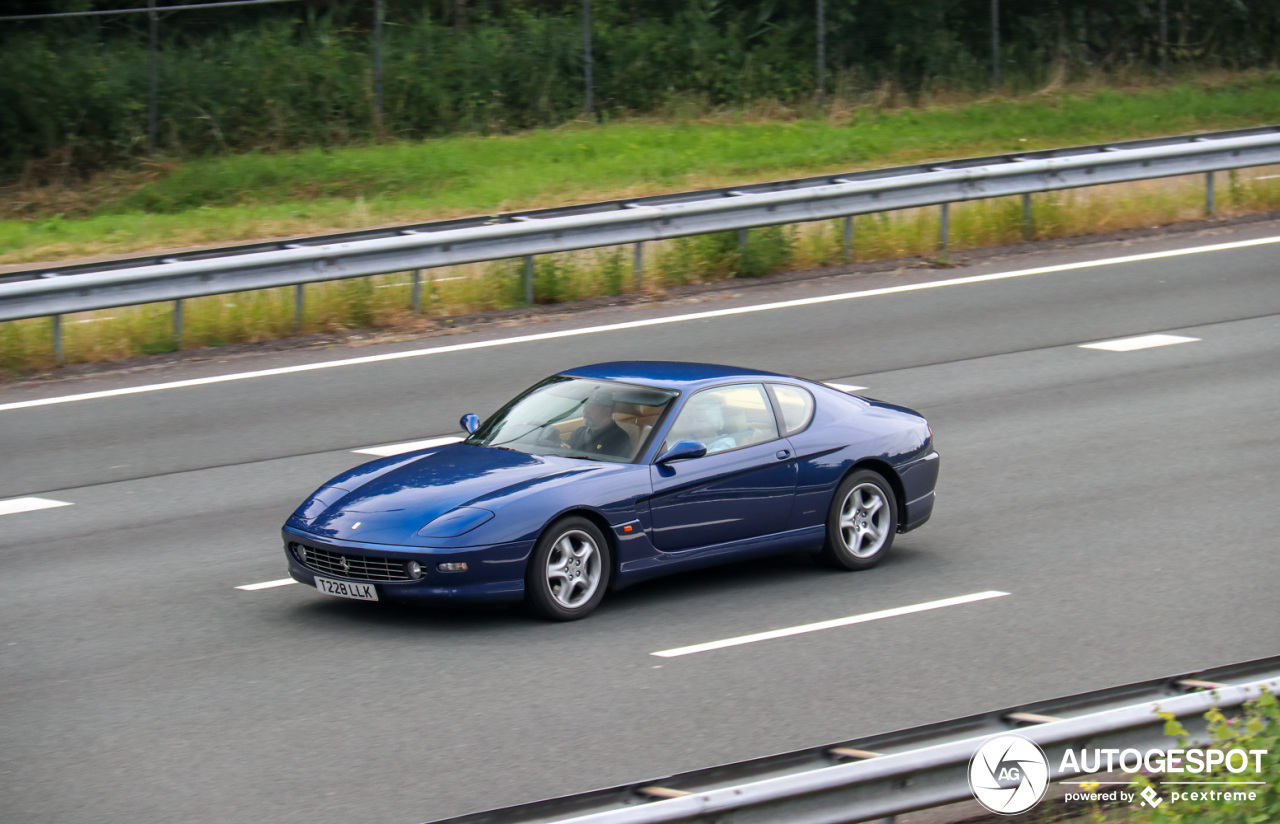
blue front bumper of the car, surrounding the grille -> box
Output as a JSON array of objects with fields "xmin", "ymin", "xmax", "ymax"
[{"xmin": 282, "ymin": 527, "xmax": 534, "ymax": 603}]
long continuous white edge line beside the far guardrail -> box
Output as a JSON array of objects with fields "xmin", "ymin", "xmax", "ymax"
[{"xmin": 0, "ymin": 237, "xmax": 1280, "ymax": 412}]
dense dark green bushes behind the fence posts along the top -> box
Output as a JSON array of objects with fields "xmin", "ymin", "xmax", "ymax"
[{"xmin": 0, "ymin": 0, "xmax": 1280, "ymax": 183}]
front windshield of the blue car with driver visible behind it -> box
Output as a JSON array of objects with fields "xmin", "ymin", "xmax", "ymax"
[{"xmin": 466, "ymin": 375, "xmax": 676, "ymax": 463}]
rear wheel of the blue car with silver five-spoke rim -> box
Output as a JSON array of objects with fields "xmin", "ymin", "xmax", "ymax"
[{"xmin": 822, "ymin": 470, "xmax": 897, "ymax": 569}]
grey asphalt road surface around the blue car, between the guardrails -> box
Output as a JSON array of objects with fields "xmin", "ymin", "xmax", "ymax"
[{"xmin": 0, "ymin": 224, "xmax": 1280, "ymax": 824}]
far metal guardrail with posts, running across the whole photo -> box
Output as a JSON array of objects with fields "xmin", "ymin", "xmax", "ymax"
[{"xmin": 0, "ymin": 127, "xmax": 1280, "ymax": 360}]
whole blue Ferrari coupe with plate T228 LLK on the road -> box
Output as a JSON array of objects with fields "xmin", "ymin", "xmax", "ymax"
[{"xmin": 284, "ymin": 362, "xmax": 938, "ymax": 621}]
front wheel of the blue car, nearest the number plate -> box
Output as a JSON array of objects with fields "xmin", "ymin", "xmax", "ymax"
[{"xmin": 525, "ymin": 517, "xmax": 613, "ymax": 621}]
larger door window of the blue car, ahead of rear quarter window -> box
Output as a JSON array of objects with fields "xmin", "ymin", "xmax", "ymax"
[{"xmin": 667, "ymin": 384, "xmax": 778, "ymax": 454}]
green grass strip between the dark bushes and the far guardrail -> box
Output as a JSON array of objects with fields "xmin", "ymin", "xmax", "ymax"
[{"xmin": 0, "ymin": 73, "xmax": 1280, "ymax": 264}]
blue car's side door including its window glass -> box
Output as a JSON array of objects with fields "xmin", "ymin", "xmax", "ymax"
[{"xmin": 649, "ymin": 384, "xmax": 796, "ymax": 551}]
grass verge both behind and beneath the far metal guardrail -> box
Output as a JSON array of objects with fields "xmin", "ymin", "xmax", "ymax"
[{"xmin": 0, "ymin": 73, "xmax": 1280, "ymax": 374}]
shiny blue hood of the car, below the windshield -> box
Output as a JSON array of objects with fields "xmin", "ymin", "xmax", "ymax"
[{"xmin": 289, "ymin": 444, "xmax": 607, "ymax": 545}]
